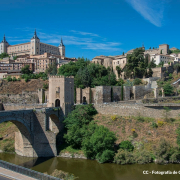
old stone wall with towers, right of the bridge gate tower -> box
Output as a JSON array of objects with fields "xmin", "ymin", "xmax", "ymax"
[{"xmin": 76, "ymin": 86, "xmax": 152, "ymax": 104}]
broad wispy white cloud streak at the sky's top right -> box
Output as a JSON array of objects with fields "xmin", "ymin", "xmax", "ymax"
[{"xmin": 126, "ymin": 0, "xmax": 167, "ymax": 27}]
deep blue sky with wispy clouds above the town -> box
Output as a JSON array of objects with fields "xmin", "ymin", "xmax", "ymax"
[{"xmin": 0, "ymin": 0, "xmax": 180, "ymax": 59}]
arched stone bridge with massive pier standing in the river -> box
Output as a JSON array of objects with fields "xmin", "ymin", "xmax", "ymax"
[{"xmin": 0, "ymin": 107, "xmax": 64, "ymax": 157}]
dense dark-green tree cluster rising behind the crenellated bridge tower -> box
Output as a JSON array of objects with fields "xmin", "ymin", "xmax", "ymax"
[{"xmin": 58, "ymin": 58, "xmax": 117, "ymax": 88}]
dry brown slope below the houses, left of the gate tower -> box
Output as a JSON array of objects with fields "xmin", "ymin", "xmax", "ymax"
[{"xmin": 0, "ymin": 79, "xmax": 48, "ymax": 94}]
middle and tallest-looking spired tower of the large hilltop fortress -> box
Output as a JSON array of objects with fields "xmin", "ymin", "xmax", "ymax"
[{"xmin": 31, "ymin": 29, "xmax": 40, "ymax": 55}]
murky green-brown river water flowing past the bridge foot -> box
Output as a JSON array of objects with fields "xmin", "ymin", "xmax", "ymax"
[{"xmin": 0, "ymin": 153, "xmax": 180, "ymax": 180}]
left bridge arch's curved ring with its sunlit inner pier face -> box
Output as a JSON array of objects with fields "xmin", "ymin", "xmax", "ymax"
[{"xmin": 0, "ymin": 116, "xmax": 34, "ymax": 157}]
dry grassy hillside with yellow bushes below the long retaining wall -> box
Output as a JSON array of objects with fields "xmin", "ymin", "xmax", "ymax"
[{"xmin": 94, "ymin": 114, "xmax": 180, "ymax": 151}]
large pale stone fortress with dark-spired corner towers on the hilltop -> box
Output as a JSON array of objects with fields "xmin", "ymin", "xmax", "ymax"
[{"xmin": 0, "ymin": 30, "xmax": 65, "ymax": 57}]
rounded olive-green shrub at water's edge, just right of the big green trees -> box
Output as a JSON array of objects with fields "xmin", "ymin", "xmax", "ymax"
[{"xmin": 114, "ymin": 149, "xmax": 134, "ymax": 164}]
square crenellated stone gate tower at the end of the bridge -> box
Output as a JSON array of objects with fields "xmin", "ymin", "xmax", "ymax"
[{"xmin": 47, "ymin": 76, "xmax": 74, "ymax": 115}]
